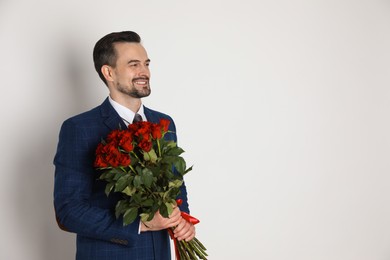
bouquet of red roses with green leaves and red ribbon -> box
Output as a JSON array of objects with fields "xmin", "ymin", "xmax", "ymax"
[{"xmin": 94, "ymin": 119, "xmax": 207, "ymax": 259}]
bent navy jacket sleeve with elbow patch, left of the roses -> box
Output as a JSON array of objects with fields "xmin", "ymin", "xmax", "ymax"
[{"xmin": 54, "ymin": 120, "xmax": 139, "ymax": 247}]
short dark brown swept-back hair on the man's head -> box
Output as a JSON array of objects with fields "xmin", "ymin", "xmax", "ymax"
[{"xmin": 93, "ymin": 31, "xmax": 141, "ymax": 85}]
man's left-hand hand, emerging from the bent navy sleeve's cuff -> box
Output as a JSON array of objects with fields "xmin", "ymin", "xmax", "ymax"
[{"xmin": 141, "ymin": 207, "xmax": 182, "ymax": 232}]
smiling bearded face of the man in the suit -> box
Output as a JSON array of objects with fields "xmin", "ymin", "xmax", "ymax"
[{"xmin": 112, "ymin": 43, "xmax": 151, "ymax": 98}]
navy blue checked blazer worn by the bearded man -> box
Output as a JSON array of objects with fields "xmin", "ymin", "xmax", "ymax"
[{"xmin": 54, "ymin": 99, "xmax": 189, "ymax": 260}]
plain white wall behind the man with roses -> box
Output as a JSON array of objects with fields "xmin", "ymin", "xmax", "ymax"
[{"xmin": 0, "ymin": 0, "xmax": 390, "ymax": 260}]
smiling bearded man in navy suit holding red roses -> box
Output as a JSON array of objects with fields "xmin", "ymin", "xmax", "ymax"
[{"xmin": 54, "ymin": 31, "xmax": 195, "ymax": 260}]
